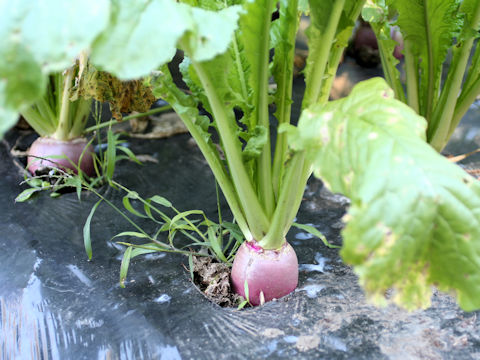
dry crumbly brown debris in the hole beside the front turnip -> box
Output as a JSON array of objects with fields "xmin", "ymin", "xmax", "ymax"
[{"xmin": 193, "ymin": 256, "xmax": 243, "ymax": 307}]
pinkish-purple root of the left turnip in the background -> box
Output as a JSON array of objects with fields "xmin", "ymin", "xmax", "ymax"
[{"xmin": 27, "ymin": 137, "xmax": 95, "ymax": 176}]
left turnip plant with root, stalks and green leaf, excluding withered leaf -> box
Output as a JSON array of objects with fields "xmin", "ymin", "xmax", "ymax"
[{"xmin": 0, "ymin": 1, "xmax": 109, "ymax": 175}]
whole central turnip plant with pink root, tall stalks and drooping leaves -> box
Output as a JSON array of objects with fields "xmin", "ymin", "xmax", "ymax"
[{"xmin": 0, "ymin": 0, "xmax": 480, "ymax": 310}]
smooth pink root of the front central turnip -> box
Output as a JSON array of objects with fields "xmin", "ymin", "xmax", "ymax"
[{"xmin": 231, "ymin": 241, "xmax": 298, "ymax": 306}]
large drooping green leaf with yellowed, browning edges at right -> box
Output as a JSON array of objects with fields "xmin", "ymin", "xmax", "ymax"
[{"xmin": 284, "ymin": 78, "xmax": 480, "ymax": 310}]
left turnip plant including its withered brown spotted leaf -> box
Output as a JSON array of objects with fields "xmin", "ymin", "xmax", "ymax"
[{"xmin": 0, "ymin": 1, "xmax": 161, "ymax": 179}]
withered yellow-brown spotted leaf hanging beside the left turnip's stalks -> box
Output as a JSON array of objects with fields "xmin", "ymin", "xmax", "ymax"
[{"xmin": 70, "ymin": 63, "xmax": 156, "ymax": 120}]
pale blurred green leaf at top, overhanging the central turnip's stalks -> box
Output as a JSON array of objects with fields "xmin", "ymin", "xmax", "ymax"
[{"xmin": 91, "ymin": 0, "xmax": 241, "ymax": 79}]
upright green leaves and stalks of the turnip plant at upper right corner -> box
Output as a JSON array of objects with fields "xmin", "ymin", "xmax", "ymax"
[{"xmin": 363, "ymin": 0, "xmax": 480, "ymax": 151}]
